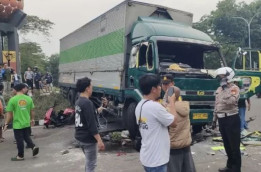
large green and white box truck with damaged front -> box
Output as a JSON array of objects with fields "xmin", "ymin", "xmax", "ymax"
[{"xmin": 59, "ymin": 1, "xmax": 258, "ymax": 138}]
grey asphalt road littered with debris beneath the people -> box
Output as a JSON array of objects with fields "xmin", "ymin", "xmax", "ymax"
[{"xmin": 0, "ymin": 97, "xmax": 261, "ymax": 172}]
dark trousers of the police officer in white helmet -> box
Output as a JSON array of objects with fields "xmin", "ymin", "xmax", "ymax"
[{"xmin": 218, "ymin": 114, "xmax": 241, "ymax": 172}]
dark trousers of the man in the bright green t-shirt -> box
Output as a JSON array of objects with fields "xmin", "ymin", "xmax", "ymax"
[{"xmin": 14, "ymin": 127, "xmax": 35, "ymax": 158}]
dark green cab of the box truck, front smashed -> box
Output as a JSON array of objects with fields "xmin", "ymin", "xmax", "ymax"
[{"xmin": 125, "ymin": 17, "xmax": 226, "ymax": 136}]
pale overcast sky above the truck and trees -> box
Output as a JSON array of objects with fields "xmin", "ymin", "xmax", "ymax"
[{"xmin": 23, "ymin": 0, "xmax": 253, "ymax": 56}]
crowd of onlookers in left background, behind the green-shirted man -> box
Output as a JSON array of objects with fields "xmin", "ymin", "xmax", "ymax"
[{"xmin": 0, "ymin": 64, "xmax": 53, "ymax": 95}]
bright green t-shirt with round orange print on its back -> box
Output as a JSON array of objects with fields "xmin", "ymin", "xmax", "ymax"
[{"xmin": 6, "ymin": 94, "xmax": 34, "ymax": 129}]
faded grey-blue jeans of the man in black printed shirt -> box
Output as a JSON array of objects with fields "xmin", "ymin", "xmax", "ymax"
[{"xmin": 78, "ymin": 142, "xmax": 98, "ymax": 172}]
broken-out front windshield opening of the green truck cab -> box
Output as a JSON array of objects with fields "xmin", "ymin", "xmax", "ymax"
[{"xmin": 157, "ymin": 41, "xmax": 222, "ymax": 69}]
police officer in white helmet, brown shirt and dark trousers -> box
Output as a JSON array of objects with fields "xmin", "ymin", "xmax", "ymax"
[{"xmin": 212, "ymin": 67, "xmax": 241, "ymax": 172}]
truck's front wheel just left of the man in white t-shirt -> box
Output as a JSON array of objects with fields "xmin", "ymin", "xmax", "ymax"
[{"xmin": 126, "ymin": 102, "xmax": 139, "ymax": 139}]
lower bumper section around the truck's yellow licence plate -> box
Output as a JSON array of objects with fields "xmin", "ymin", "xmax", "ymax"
[{"xmin": 189, "ymin": 109, "xmax": 213, "ymax": 125}]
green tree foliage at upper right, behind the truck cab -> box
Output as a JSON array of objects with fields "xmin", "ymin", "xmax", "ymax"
[{"xmin": 194, "ymin": 0, "xmax": 261, "ymax": 66}]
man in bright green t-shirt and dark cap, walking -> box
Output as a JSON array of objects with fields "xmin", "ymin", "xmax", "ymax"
[{"xmin": 4, "ymin": 83, "xmax": 39, "ymax": 161}]
